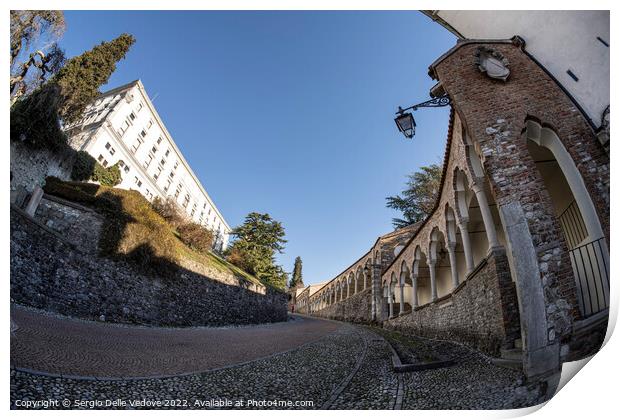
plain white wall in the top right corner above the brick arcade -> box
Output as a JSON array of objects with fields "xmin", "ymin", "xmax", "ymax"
[{"xmin": 435, "ymin": 10, "xmax": 610, "ymax": 127}]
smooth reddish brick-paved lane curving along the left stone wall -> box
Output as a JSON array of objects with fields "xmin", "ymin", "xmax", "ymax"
[{"xmin": 11, "ymin": 307, "xmax": 338, "ymax": 378}]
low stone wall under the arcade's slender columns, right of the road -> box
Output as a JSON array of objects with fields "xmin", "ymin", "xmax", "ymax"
[{"xmin": 383, "ymin": 250, "xmax": 520, "ymax": 356}]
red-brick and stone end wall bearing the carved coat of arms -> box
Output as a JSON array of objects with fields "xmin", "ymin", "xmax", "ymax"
[{"xmin": 434, "ymin": 43, "xmax": 609, "ymax": 343}]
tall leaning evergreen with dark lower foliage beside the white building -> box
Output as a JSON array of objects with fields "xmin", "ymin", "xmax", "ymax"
[{"xmin": 11, "ymin": 34, "xmax": 134, "ymax": 149}]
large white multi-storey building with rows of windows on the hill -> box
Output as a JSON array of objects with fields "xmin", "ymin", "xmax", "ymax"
[{"xmin": 66, "ymin": 80, "xmax": 231, "ymax": 250}]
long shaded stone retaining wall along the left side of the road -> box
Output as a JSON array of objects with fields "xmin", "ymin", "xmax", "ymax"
[{"xmin": 10, "ymin": 207, "xmax": 287, "ymax": 326}]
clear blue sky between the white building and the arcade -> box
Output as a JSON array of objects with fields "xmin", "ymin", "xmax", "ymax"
[{"xmin": 61, "ymin": 11, "xmax": 455, "ymax": 284}]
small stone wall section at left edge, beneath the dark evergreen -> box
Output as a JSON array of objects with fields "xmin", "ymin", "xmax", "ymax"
[{"xmin": 10, "ymin": 141, "xmax": 74, "ymax": 206}]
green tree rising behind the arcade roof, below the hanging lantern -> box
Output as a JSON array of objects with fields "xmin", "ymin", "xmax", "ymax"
[{"xmin": 386, "ymin": 164, "xmax": 442, "ymax": 229}]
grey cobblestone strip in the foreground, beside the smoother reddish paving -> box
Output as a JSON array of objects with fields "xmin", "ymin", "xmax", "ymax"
[{"xmin": 11, "ymin": 306, "xmax": 542, "ymax": 409}]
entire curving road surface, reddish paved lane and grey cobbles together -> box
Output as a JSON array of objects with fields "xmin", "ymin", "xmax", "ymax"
[{"xmin": 11, "ymin": 309, "xmax": 542, "ymax": 409}]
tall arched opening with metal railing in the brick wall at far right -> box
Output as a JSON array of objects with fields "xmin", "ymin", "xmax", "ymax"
[{"xmin": 526, "ymin": 121, "xmax": 609, "ymax": 317}]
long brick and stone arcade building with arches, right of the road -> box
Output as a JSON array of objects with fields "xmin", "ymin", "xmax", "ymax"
[{"xmin": 298, "ymin": 12, "xmax": 610, "ymax": 378}]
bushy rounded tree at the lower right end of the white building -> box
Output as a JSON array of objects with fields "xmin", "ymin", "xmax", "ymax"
[{"xmin": 228, "ymin": 212, "xmax": 287, "ymax": 290}]
